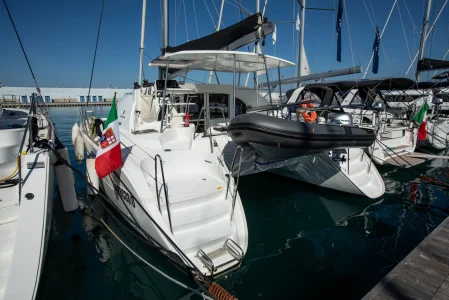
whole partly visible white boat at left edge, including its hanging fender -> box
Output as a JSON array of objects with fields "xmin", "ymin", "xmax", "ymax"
[{"xmin": 0, "ymin": 94, "xmax": 78, "ymax": 299}]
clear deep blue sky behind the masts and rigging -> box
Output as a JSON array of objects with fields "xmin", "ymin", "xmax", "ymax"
[{"xmin": 0, "ymin": 0, "xmax": 449, "ymax": 88}]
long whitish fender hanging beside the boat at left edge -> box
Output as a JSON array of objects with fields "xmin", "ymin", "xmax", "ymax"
[{"xmin": 55, "ymin": 142, "xmax": 78, "ymax": 211}]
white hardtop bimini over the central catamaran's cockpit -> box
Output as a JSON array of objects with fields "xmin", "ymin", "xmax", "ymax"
[{"xmin": 149, "ymin": 50, "xmax": 295, "ymax": 73}]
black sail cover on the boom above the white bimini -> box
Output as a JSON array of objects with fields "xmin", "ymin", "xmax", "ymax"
[{"xmin": 162, "ymin": 13, "xmax": 274, "ymax": 55}]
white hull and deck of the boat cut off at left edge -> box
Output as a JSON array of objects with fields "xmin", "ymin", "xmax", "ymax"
[{"xmin": 0, "ymin": 110, "xmax": 56, "ymax": 300}]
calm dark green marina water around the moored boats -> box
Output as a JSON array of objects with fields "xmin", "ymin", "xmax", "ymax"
[{"xmin": 38, "ymin": 107, "xmax": 448, "ymax": 300}]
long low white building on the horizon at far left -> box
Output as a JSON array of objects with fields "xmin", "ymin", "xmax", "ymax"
[{"xmin": 0, "ymin": 86, "xmax": 133, "ymax": 103}]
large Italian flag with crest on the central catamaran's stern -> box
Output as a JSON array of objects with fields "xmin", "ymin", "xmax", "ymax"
[{"xmin": 95, "ymin": 93, "xmax": 122, "ymax": 178}]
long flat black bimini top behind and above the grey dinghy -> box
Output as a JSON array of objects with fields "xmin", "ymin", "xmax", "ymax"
[{"xmin": 306, "ymin": 78, "xmax": 415, "ymax": 91}]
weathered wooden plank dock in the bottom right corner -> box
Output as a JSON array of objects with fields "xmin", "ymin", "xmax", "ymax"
[{"xmin": 363, "ymin": 218, "xmax": 449, "ymax": 300}]
